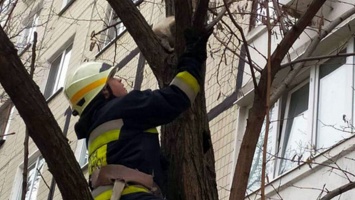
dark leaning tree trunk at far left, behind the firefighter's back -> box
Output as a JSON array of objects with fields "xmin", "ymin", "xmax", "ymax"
[{"xmin": 0, "ymin": 28, "xmax": 92, "ymax": 200}]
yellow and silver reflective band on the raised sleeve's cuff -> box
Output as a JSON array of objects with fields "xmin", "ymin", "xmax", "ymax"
[{"xmin": 171, "ymin": 71, "xmax": 200, "ymax": 103}]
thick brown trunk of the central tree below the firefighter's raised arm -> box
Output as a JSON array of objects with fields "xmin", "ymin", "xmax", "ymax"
[{"xmin": 162, "ymin": 89, "xmax": 218, "ymax": 200}]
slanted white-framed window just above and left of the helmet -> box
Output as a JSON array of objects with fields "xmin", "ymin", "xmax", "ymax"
[{"xmin": 44, "ymin": 45, "xmax": 72, "ymax": 99}]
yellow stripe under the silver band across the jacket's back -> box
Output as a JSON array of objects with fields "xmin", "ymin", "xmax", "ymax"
[{"xmin": 89, "ymin": 129, "xmax": 121, "ymax": 155}]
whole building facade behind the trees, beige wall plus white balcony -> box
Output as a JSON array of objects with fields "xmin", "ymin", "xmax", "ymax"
[{"xmin": 4, "ymin": 0, "xmax": 355, "ymax": 200}]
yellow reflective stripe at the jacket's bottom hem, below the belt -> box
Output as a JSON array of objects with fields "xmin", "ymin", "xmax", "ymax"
[{"xmin": 93, "ymin": 185, "xmax": 150, "ymax": 200}]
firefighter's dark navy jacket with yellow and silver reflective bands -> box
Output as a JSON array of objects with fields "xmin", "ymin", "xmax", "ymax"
[{"xmin": 75, "ymin": 57, "xmax": 201, "ymax": 200}]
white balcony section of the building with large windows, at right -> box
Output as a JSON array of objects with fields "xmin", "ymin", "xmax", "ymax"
[{"xmin": 236, "ymin": 0, "xmax": 355, "ymax": 200}]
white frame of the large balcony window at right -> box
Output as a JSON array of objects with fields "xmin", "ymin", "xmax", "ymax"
[{"xmin": 239, "ymin": 38, "xmax": 355, "ymax": 194}]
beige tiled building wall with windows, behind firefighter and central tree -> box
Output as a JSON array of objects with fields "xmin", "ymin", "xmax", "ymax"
[{"xmin": 0, "ymin": 0, "xmax": 247, "ymax": 200}]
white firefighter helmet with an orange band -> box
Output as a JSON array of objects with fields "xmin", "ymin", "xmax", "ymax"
[{"xmin": 64, "ymin": 62, "xmax": 116, "ymax": 116}]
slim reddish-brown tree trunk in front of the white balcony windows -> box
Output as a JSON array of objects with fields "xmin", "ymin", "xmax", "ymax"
[{"xmin": 229, "ymin": 0, "xmax": 325, "ymax": 200}]
